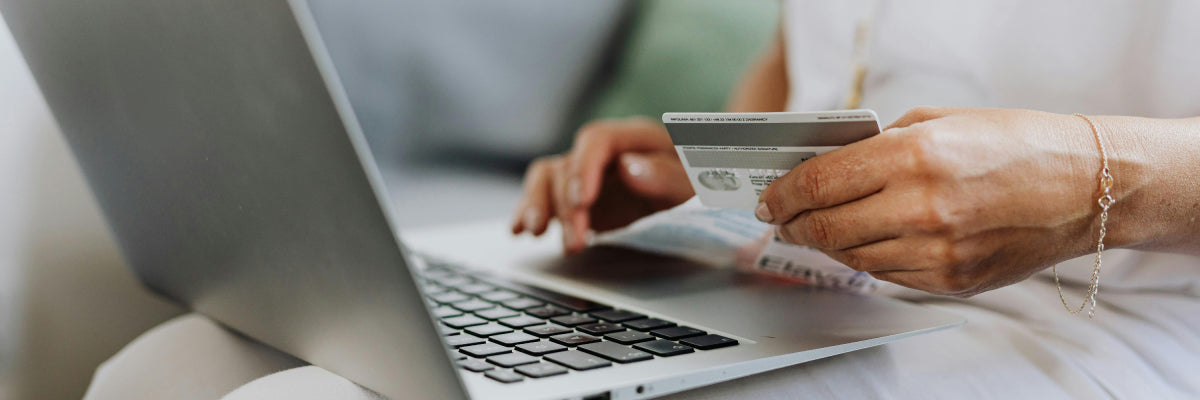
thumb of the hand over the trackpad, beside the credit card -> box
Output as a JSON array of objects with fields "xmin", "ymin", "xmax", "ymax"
[{"xmin": 618, "ymin": 153, "xmax": 696, "ymax": 204}]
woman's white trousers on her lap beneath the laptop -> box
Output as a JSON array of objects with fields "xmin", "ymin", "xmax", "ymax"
[{"xmin": 86, "ymin": 242, "xmax": 1200, "ymax": 400}]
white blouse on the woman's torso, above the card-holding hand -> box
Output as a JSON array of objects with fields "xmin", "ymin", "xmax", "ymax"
[{"xmin": 784, "ymin": 0, "xmax": 1200, "ymax": 124}]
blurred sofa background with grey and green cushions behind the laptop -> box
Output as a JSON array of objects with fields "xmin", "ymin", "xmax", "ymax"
[{"xmin": 0, "ymin": 0, "xmax": 778, "ymax": 399}]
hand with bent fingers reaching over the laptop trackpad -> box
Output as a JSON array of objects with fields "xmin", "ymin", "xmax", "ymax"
[{"xmin": 512, "ymin": 118, "xmax": 695, "ymax": 252}]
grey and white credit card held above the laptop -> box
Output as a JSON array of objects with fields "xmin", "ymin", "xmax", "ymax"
[{"xmin": 662, "ymin": 109, "xmax": 880, "ymax": 209}]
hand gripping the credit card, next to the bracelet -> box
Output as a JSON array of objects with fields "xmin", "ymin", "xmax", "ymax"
[{"xmin": 756, "ymin": 107, "xmax": 1121, "ymax": 297}]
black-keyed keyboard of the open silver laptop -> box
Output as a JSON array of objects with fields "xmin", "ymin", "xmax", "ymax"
[{"xmin": 421, "ymin": 263, "xmax": 738, "ymax": 383}]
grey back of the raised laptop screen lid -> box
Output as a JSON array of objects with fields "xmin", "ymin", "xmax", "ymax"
[{"xmin": 0, "ymin": 0, "xmax": 466, "ymax": 399}]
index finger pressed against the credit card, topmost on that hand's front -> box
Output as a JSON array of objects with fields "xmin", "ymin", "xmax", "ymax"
[{"xmin": 755, "ymin": 135, "xmax": 896, "ymax": 225}]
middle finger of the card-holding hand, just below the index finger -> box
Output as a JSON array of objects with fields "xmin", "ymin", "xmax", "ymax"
[{"xmin": 778, "ymin": 190, "xmax": 937, "ymax": 250}]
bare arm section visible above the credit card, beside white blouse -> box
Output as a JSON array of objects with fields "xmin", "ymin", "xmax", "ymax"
[{"xmin": 725, "ymin": 27, "xmax": 788, "ymax": 113}]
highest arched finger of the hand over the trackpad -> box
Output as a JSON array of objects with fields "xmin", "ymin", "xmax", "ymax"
[{"xmin": 566, "ymin": 118, "xmax": 674, "ymax": 208}]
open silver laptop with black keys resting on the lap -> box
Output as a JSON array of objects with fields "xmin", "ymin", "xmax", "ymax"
[{"xmin": 0, "ymin": 0, "xmax": 964, "ymax": 399}]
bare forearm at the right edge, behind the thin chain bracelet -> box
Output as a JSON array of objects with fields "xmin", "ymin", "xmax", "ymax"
[{"xmin": 1092, "ymin": 117, "xmax": 1200, "ymax": 255}]
